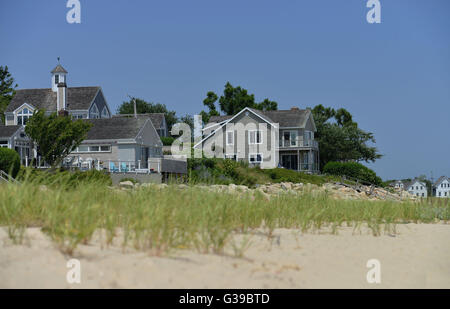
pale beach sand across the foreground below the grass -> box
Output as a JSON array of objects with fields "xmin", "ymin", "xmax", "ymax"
[{"xmin": 0, "ymin": 224, "xmax": 450, "ymax": 289}]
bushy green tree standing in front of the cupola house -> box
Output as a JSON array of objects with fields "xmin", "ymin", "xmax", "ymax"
[{"xmin": 25, "ymin": 110, "xmax": 92, "ymax": 167}]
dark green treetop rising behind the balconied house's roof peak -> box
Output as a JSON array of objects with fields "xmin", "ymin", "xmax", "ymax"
[{"xmin": 201, "ymin": 82, "xmax": 278, "ymax": 122}]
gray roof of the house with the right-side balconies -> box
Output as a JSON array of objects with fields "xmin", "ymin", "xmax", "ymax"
[{"xmin": 209, "ymin": 108, "xmax": 311, "ymax": 128}]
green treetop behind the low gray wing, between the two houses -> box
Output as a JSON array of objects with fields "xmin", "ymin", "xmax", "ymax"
[{"xmin": 117, "ymin": 97, "xmax": 178, "ymax": 131}]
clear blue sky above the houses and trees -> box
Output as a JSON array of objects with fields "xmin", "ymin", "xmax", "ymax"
[{"xmin": 0, "ymin": 0, "xmax": 450, "ymax": 179}]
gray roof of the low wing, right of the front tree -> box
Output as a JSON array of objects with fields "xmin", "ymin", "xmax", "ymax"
[{"xmin": 84, "ymin": 117, "xmax": 153, "ymax": 140}]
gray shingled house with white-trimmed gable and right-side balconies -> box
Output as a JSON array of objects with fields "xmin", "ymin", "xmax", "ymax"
[{"xmin": 195, "ymin": 107, "xmax": 319, "ymax": 173}]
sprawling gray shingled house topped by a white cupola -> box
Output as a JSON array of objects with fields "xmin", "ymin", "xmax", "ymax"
[{"xmin": 0, "ymin": 64, "xmax": 186, "ymax": 174}]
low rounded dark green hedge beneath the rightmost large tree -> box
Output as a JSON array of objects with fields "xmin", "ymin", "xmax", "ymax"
[{"xmin": 323, "ymin": 162, "xmax": 383, "ymax": 186}]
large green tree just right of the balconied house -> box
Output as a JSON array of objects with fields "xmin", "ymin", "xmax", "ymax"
[{"xmin": 312, "ymin": 105, "xmax": 382, "ymax": 168}]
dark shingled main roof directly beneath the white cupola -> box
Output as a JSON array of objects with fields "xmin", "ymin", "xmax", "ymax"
[{"xmin": 6, "ymin": 87, "xmax": 101, "ymax": 112}]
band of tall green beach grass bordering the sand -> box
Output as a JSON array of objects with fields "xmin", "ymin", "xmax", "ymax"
[{"xmin": 0, "ymin": 180, "xmax": 450, "ymax": 256}]
